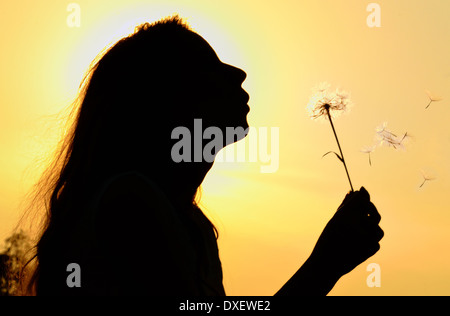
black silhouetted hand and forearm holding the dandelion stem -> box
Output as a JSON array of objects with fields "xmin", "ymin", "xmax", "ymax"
[{"xmin": 276, "ymin": 188, "xmax": 384, "ymax": 295}]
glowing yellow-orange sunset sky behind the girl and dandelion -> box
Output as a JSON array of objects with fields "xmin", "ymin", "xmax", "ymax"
[{"xmin": 0, "ymin": 0, "xmax": 450, "ymax": 295}]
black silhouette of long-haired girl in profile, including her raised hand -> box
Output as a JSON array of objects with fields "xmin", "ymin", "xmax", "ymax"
[{"xmin": 26, "ymin": 16, "xmax": 383, "ymax": 296}]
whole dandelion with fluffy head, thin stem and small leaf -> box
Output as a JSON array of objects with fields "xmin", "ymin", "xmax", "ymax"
[{"xmin": 307, "ymin": 82, "xmax": 354, "ymax": 192}]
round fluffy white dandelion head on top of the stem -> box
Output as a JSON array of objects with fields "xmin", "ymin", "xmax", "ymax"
[{"xmin": 306, "ymin": 82, "xmax": 352, "ymax": 119}]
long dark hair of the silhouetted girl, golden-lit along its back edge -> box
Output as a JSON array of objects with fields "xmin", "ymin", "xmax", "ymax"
[{"xmin": 24, "ymin": 16, "xmax": 217, "ymax": 292}]
